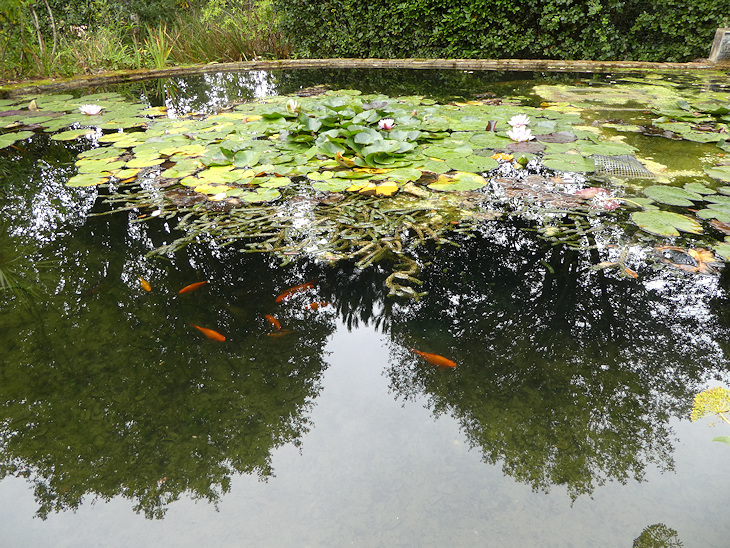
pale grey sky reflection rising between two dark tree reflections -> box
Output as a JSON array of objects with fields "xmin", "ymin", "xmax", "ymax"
[{"xmin": 0, "ymin": 318, "xmax": 730, "ymax": 547}]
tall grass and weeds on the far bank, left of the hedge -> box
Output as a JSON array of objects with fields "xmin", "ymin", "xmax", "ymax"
[{"xmin": 0, "ymin": 0, "xmax": 292, "ymax": 81}]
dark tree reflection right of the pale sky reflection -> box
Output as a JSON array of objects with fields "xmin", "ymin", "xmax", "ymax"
[{"xmin": 390, "ymin": 220, "xmax": 728, "ymax": 497}]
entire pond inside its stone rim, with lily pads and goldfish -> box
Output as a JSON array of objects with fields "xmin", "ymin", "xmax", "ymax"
[{"xmin": 0, "ymin": 70, "xmax": 730, "ymax": 546}]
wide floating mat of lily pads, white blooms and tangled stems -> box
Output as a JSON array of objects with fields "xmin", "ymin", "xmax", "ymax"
[{"xmin": 0, "ymin": 77, "xmax": 730, "ymax": 296}]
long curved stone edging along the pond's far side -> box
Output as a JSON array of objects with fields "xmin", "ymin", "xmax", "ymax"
[{"xmin": 0, "ymin": 59, "xmax": 730, "ymax": 98}]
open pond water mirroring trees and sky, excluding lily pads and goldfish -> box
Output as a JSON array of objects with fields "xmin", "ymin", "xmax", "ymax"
[{"xmin": 0, "ymin": 71, "xmax": 730, "ymax": 546}]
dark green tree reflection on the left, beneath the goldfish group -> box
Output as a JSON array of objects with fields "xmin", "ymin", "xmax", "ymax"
[{"xmin": 0, "ymin": 206, "xmax": 332, "ymax": 517}]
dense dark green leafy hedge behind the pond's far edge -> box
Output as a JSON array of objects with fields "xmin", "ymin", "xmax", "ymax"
[{"xmin": 274, "ymin": 0, "xmax": 730, "ymax": 61}]
